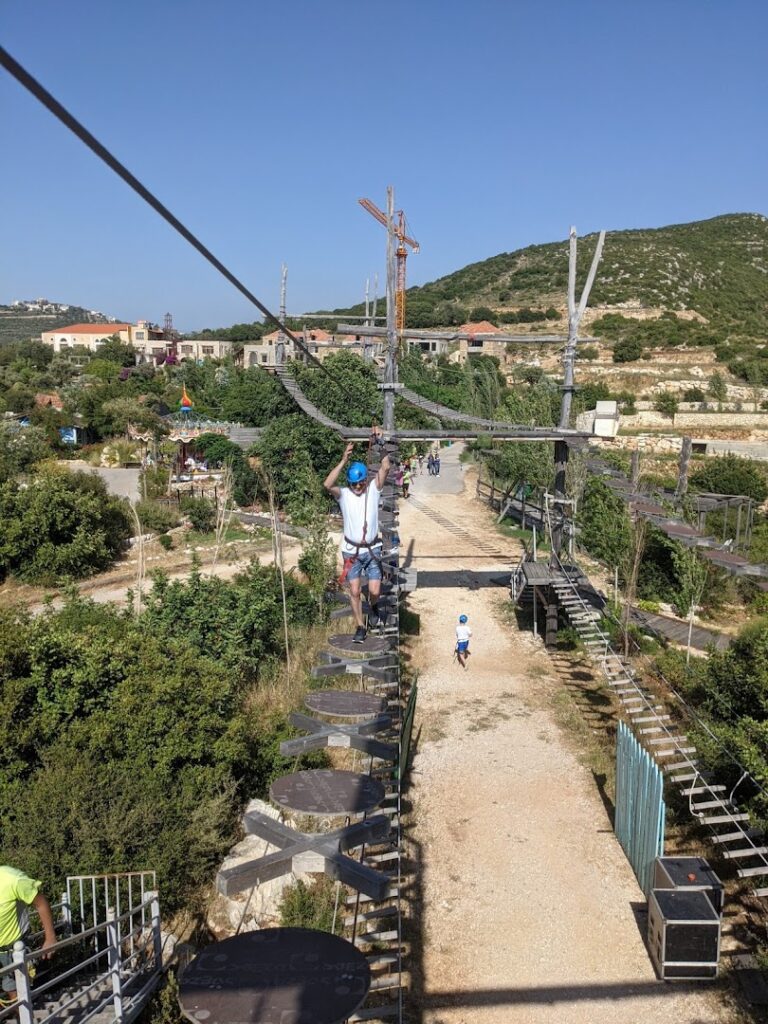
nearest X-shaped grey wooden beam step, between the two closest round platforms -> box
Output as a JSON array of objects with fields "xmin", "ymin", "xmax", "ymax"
[{"xmin": 216, "ymin": 811, "xmax": 390, "ymax": 900}]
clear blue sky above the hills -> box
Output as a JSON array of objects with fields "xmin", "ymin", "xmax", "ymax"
[{"xmin": 0, "ymin": 0, "xmax": 768, "ymax": 330}]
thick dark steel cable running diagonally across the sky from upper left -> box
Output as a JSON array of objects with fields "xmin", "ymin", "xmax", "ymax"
[{"xmin": 0, "ymin": 46, "xmax": 348, "ymax": 398}]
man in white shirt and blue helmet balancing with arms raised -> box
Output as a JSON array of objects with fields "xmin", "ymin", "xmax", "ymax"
[{"xmin": 324, "ymin": 435, "xmax": 390, "ymax": 643}]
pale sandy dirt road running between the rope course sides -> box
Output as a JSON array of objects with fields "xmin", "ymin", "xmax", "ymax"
[{"xmin": 400, "ymin": 447, "xmax": 742, "ymax": 1024}]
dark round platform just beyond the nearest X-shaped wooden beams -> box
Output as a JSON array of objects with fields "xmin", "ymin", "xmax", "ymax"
[{"xmin": 269, "ymin": 768, "xmax": 384, "ymax": 814}]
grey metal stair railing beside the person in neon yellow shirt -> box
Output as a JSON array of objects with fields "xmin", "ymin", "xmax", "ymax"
[{"xmin": 0, "ymin": 871, "xmax": 163, "ymax": 1024}]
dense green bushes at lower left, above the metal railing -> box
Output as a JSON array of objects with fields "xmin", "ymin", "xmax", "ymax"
[{"xmin": 0, "ymin": 565, "xmax": 317, "ymax": 912}]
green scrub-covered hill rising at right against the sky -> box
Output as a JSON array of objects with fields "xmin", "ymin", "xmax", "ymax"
[{"xmin": 325, "ymin": 213, "xmax": 768, "ymax": 337}]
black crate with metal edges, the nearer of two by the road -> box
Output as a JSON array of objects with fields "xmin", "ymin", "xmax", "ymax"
[{"xmin": 648, "ymin": 889, "xmax": 720, "ymax": 981}]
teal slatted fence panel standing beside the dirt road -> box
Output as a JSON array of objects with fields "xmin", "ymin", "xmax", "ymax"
[{"xmin": 613, "ymin": 722, "xmax": 666, "ymax": 896}]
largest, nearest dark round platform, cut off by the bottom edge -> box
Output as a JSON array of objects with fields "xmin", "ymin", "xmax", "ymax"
[{"xmin": 179, "ymin": 928, "xmax": 371, "ymax": 1024}]
